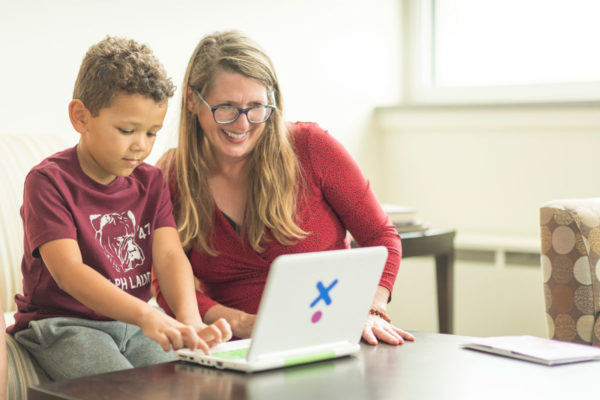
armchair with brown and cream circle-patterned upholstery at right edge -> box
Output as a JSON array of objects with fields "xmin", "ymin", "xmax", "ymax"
[{"xmin": 540, "ymin": 198, "xmax": 600, "ymax": 346}]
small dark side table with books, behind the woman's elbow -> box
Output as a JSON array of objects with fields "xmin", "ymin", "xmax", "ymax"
[{"xmin": 400, "ymin": 229, "xmax": 456, "ymax": 333}]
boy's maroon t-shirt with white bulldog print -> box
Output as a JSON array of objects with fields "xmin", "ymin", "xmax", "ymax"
[{"xmin": 8, "ymin": 147, "xmax": 175, "ymax": 333}]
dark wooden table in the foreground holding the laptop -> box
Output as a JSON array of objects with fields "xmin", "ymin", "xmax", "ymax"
[{"xmin": 28, "ymin": 332, "xmax": 600, "ymax": 400}]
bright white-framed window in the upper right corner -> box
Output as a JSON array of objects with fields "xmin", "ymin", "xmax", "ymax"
[{"xmin": 405, "ymin": 0, "xmax": 600, "ymax": 103}]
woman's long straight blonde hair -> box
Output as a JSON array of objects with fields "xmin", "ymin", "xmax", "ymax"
[{"xmin": 166, "ymin": 31, "xmax": 306, "ymax": 255}]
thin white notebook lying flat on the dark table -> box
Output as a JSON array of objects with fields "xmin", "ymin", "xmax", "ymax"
[{"xmin": 461, "ymin": 336, "xmax": 600, "ymax": 365}]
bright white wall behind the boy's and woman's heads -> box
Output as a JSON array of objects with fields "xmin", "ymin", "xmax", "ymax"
[{"xmin": 0, "ymin": 0, "xmax": 400, "ymax": 162}]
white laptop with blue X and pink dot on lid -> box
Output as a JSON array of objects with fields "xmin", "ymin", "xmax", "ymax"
[{"xmin": 177, "ymin": 246, "xmax": 387, "ymax": 372}]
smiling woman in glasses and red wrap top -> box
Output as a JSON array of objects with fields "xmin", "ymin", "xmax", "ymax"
[{"xmin": 155, "ymin": 31, "xmax": 413, "ymax": 344}]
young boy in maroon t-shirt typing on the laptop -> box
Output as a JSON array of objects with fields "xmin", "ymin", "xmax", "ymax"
[{"xmin": 9, "ymin": 37, "xmax": 231, "ymax": 380}]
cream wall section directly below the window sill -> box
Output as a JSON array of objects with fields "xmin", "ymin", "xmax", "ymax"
[{"xmin": 375, "ymin": 105, "xmax": 600, "ymax": 239}]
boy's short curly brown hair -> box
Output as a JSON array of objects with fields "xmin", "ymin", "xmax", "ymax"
[{"xmin": 73, "ymin": 36, "xmax": 175, "ymax": 117}]
